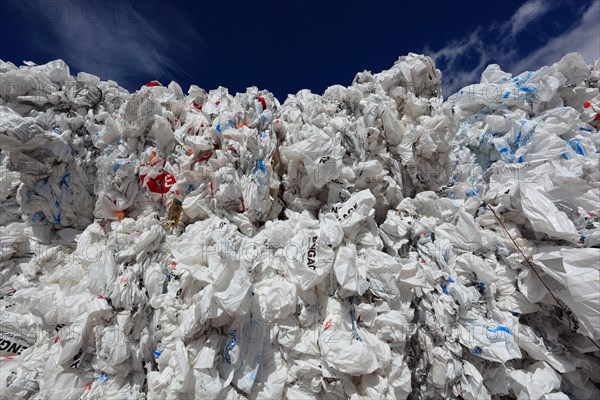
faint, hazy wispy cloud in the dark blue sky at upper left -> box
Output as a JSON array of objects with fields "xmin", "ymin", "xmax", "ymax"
[{"xmin": 31, "ymin": 0, "xmax": 206, "ymax": 87}]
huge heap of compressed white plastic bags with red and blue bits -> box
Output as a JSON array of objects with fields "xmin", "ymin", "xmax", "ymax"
[{"xmin": 0, "ymin": 53, "xmax": 600, "ymax": 400}]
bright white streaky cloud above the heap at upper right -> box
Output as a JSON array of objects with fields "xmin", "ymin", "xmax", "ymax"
[{"xmin": 424, "ymin": 0, "xmax": 600, "ymax": 96}]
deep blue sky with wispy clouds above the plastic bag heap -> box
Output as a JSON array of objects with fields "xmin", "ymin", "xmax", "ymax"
[{"xmin": 0, "ymin": 0, "xmax": 600, "ymax": 101}]
